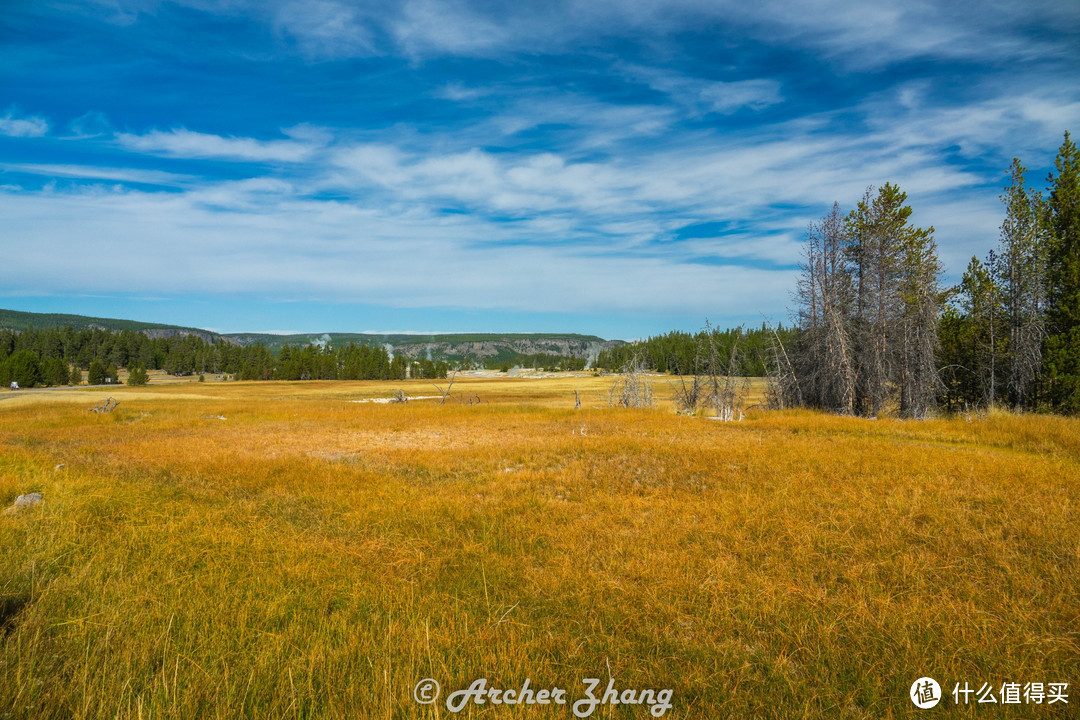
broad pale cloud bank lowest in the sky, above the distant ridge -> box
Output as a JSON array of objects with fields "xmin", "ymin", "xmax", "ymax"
[{"xmin": 0, "ymin": 174, "xmax": 791, "ymax": 314}]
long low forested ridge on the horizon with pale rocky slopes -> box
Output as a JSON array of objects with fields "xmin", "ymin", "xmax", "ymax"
[{"xmin": 0, "ymin": 310, "xmax": 624, "ymax": 362}]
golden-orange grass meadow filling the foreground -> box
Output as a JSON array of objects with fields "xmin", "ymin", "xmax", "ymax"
[{"xmin": 0, "ymin": 376, "xmax": 1080, "ymax": 719}]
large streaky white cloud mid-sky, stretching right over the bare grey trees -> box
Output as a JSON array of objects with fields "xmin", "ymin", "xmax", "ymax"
[{"xmin": 312, "ymin": 107, "xmax": 984, "ymax": 248}]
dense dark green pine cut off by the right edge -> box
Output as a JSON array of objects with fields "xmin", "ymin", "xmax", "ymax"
[{"xmin": 1043, "ymin": 133, "xmax": 1080, "ymax": 413}]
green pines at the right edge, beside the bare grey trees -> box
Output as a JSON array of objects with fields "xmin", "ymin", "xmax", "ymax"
[{"xmin": 942, "ymin": 133, "xmax": 1080, "ymax": 413}]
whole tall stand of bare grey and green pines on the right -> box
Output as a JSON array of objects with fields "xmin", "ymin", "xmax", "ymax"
[{"xmin": 774, "ymin": 133, "xmax": 1080, "ymax": 418}]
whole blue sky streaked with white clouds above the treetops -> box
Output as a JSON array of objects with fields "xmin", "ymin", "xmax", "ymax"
[{"xmin": 0, "ymin": 0, "xmax": 1080, "ymax": 338}]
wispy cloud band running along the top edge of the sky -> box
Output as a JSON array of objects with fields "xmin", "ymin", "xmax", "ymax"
[{"xmin": 248, "ymin": 0, "xmax": 1080, "ymax": 66}]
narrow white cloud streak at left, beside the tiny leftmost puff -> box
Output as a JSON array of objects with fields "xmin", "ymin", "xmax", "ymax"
[{"xmin": 117, "ymin": 128, "xmax": 316, "ymax": 162}]
